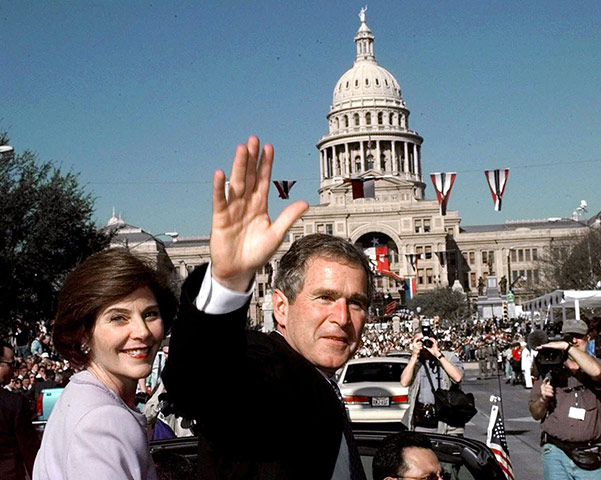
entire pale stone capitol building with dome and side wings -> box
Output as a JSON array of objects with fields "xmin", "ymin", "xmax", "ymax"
[{"xmin": 109, "ymin": 12, "xmax": 588, "ymax": 323}]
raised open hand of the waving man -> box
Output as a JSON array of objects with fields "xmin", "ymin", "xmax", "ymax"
[{"xmin": 211, "ymin": 136, "xmax": 309, "ymax": 292}]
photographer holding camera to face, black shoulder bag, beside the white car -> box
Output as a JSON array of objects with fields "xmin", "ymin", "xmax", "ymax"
[{"xmin": 401, "ymin": 329, "xmax": 464, "ymax": 436}]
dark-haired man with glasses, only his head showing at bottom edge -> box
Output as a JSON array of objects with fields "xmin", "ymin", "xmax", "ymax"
[{"xmin": 372, "ymin": 432, "xmax": 446, "ymax": 480}]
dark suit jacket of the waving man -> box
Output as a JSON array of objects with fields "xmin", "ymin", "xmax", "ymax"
[{"xmin": 163, "ymin": 266, "xmax": 344, "ymax": 480}]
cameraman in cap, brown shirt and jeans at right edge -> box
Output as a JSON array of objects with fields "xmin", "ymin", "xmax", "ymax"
[{"xmin": 529, "ymin": 320, "xmax": 601, "ymax": 480}]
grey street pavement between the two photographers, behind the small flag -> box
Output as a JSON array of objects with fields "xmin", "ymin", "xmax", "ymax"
[{"xmin": 462, "ymin": 363, "xmax": 543, "ymax": 480}]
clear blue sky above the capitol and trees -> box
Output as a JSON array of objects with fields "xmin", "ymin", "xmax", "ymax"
[{"xmin": 0, "ymin": 0, "xmax": 601, "ymax": 235}]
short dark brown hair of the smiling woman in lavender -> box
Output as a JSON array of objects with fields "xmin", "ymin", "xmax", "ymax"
[{"xmin": 53, "ymin": 248, "xmax": 177, "ymax": 367}]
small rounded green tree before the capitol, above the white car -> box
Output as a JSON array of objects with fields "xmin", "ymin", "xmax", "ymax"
[{"xmin": 408, "ymin": 288, "xmax": 470, "ymax": 326}]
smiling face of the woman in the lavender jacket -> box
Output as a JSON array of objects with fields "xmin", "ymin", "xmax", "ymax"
[{"xmin": 88, "ymin": 287, "xmax": 163, "ymax": 397}]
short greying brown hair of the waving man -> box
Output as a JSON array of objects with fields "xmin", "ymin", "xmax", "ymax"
[{"xmin": 273, "ymin": 233, "xmax": 374, "ymax": 303}]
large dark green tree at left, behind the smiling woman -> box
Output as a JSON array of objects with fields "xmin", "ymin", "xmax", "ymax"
[{"xmin": 0, "ymin": 133, "xmax": 109, "ymax": 329}]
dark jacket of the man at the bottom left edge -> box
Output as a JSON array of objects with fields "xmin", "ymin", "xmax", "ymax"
[{"xmin": 0, "ymin": 387, "xmax": 40, "ymax": 480}]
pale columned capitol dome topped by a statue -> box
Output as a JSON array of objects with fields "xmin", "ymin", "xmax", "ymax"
[{"xmin": 317, "ymin": 8, "xmax": 425, "ymax": 205}]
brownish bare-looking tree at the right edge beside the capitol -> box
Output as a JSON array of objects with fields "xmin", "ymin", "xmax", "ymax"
[{"xmin": 537, "ymin": 225, "xmax": 601, "ymax": 294}]
